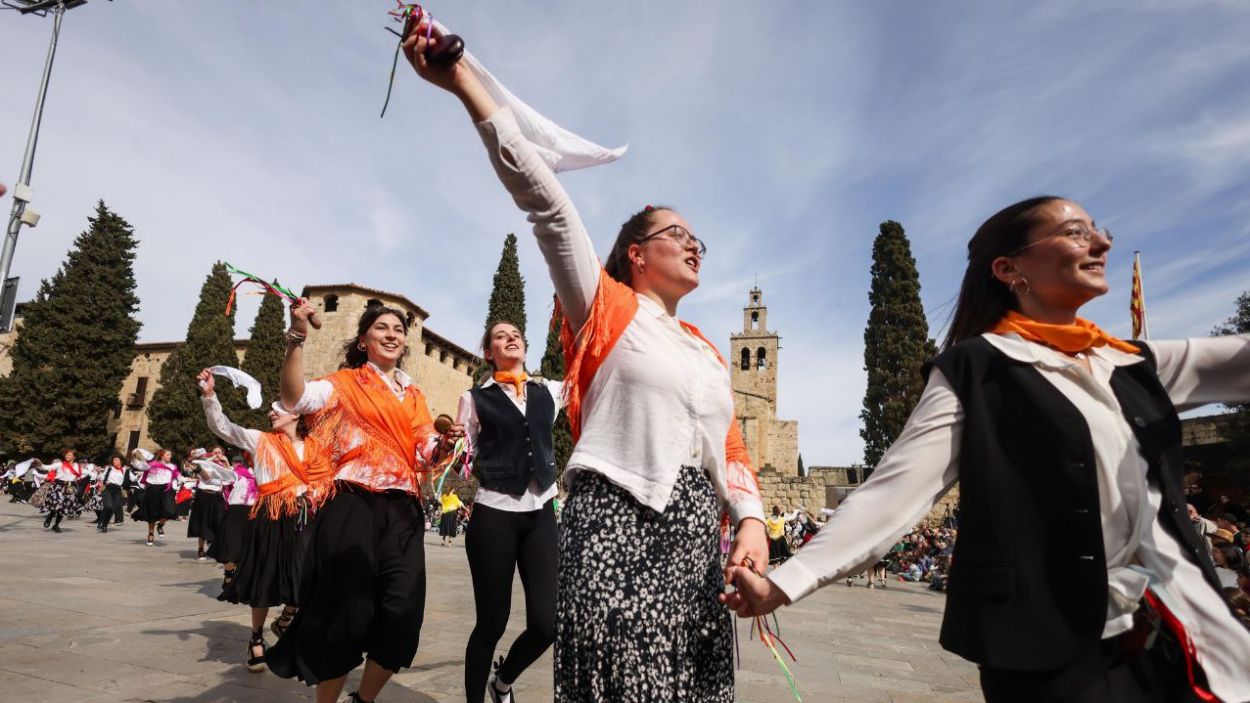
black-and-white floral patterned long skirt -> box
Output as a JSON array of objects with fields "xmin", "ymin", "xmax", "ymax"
[{"xmin": 555, "ymin": 467, "xmax": 734, "ymax": 703}]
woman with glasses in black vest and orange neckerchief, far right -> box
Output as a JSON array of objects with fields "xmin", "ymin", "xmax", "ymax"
[{"xmin": 725, "ymin": 196, "xmax": 1250, "ymax": 702}]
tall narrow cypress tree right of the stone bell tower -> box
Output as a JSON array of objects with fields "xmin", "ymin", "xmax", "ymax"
[{"xmin": 860, "ymin": 220, "xmax": 938, "ymax": 477}]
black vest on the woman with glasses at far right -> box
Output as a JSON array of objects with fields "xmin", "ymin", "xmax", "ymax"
[{"xmin": 933, "ymin": 336, "xmax": 1219, "ymax": 670}]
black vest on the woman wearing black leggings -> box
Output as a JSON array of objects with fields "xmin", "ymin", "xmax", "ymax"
[{"xmin": 470, "ymin": 383, "xmax": 555, "ymax": 495}]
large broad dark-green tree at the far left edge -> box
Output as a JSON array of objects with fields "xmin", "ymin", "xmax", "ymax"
[{"xmin": 0, "ymin": 200, "xmax": 140, "ymax": 459}]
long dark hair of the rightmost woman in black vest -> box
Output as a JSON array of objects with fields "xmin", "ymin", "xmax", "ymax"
[{"xmin": 943, "ymin": 195, "xmax": 1066, "ymax": 349}]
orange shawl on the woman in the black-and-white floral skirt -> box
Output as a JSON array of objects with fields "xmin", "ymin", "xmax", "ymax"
[{"xmin": 556, "ymin": 271, "xmax": 755, "ymax": 470}]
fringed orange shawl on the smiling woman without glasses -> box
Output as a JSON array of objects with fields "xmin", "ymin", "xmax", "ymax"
[{"xmin": 309, "ymin": 367, "xmax": 435, "ymax": 497}]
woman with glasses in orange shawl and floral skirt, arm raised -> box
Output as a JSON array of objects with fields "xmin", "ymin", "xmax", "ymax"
[{"xmin": 404, "ymin": 30, "xmax": 768, "ymax": 702}]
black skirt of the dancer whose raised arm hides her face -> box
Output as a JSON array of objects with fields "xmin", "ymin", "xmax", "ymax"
[{"xmin": 218, "ymin": 502, "xmax": 309, "ymax": 608}]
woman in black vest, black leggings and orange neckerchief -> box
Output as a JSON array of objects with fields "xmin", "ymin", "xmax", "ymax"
[{"xmin": 455, "ymin": 321, "xmax": 563, "ymax": 703}]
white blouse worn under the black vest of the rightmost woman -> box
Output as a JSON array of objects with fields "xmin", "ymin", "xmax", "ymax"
[{"xmin": 769, "ymin": 334, "xmax": 1250, "ymax": 700}]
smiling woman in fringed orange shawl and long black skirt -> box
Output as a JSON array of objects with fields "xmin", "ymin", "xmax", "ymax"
[{"xmin": 268, "ymin": 300, "xmax": 440, "ymax": 703}]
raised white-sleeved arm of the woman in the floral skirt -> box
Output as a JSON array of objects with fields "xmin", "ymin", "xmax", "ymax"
[{"xmin": 404, "ymin": 28, "xmax": 603, "ymax": 333}]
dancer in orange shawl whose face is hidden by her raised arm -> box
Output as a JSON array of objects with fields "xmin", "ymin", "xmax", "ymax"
[{"xmin": 193, "ymin": 369, "xmax": 329, "ymax": 672}]
